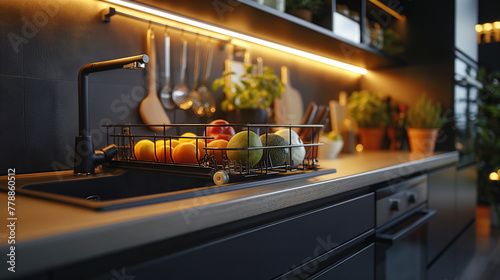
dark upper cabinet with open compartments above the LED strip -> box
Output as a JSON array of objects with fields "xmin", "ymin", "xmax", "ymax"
[{"xmin": 134, "ymin": 0, "xmax": 406, "ymax": 69}]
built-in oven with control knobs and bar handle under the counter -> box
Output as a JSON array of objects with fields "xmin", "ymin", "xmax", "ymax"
[{"xmin": 375, "ymin": 175, "xmax": 435, "ymax": 280}]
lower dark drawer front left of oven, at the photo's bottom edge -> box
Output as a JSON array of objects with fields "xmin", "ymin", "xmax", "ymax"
[{"xmin": 310, "ymin": 243, "xmax": 375, "ymax": 280}]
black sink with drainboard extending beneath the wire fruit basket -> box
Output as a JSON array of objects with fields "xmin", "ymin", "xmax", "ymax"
[{"xmin": 5, "ymin": 169, "xmax": 336, "ymax": 211}]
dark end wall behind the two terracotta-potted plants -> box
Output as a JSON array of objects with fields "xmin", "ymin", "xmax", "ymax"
[{"xmin": 362, "ymin": 0, "xmax": 455, "ymax": 153}]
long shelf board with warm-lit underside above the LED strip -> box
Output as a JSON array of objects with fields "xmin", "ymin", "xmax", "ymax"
[{"xmin": 133, "ymin": 0, "xmax": 404, "ymax": 69}]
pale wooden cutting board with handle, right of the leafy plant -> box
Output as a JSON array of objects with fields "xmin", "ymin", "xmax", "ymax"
[{"xmin": 274, "ymin": 66, "xmax": 304, "ymax": 124}]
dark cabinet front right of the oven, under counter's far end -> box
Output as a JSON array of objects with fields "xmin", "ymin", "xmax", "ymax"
[{"xmin": 427, "ymin": 164, "xmax": 477, "ymax": 280}]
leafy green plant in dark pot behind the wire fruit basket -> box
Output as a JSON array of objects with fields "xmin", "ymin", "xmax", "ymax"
[{"xmin": 212, "ymin": 65, "xmax": 285, "ymax": 123}]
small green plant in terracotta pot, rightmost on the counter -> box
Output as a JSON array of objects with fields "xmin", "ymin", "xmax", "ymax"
[{"xmin": 407, "ymin": 93, "xmax": 444, "ymax": 154}]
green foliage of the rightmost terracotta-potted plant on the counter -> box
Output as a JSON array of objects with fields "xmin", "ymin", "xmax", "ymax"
[{"xmin": 407, "ymin": 93, "xmax": 444, "ymax": 129}]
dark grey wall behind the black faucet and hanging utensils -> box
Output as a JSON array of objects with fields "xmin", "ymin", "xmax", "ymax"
[{"xmin": 0, "ymin": 0, "xmax": 360, "ymax": 174}]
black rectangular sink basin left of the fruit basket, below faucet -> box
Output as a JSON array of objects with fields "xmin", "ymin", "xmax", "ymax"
[{"xmin": 18, "ymin": 170, "xmax": 215, "ymax": 210}]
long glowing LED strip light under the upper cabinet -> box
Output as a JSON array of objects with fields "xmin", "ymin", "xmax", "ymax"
[{"xmin": 104, "ymin": 0, "xmax": 367, "ymax": 75}]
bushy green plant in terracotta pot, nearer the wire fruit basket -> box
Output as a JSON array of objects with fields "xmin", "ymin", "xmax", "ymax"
[{"xmin": 347, "ymin": 90, "xmax": 389, "ymax": 149}]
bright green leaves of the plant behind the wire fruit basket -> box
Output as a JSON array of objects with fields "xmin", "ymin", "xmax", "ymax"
[{"xmin": 212, "ymin": 65, "xmax": 285, "ymax": 111}]
